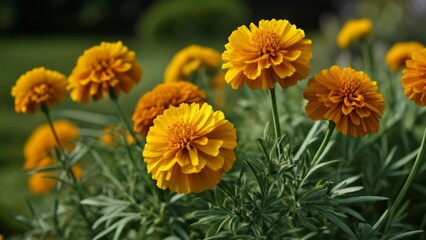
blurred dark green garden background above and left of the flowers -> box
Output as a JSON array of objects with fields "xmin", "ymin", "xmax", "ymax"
[{"xmin": 0, "ymin": 0, "xmax": 426, "ymax": 236}]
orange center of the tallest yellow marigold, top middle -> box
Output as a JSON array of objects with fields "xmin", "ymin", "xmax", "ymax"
[{"xmin": 252, "ymin": 30, "xmax": 280, "ymax": 57}]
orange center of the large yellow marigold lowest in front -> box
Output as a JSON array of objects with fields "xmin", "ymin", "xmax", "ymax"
[{"xmin": 168, "ymin": 122, "xmax": 196, "ymax": 149}]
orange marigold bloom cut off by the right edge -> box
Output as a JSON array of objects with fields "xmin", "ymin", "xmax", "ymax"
[{"xmin": 402, "ymin": 48, "xmax": 426, "ymax": 106}]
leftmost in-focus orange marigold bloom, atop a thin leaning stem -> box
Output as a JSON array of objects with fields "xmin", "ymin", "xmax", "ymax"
[{"xmin": 12, "ymin": 67, "xmax": 67, "ymax": 113}]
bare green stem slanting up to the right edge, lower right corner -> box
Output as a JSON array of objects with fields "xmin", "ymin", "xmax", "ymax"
[{"xmin": 384, "ymin": 129, "xmax": 426, "ymax": 236}]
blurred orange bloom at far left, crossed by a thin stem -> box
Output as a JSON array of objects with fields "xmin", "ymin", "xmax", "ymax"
[{"xmin": 24, "ymin": 120, "xmax": 79, "ymax": 169}]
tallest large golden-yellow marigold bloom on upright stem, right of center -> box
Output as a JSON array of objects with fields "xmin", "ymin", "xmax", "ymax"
[{"xmin": 222, "ymin": 19, "xmax": 312, "ymax": 90}]
